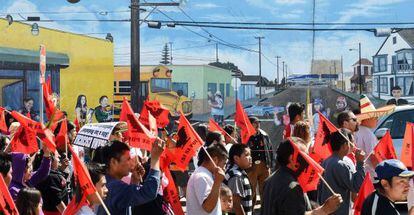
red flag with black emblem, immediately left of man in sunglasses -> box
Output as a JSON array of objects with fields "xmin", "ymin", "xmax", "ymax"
[{"xmin": 310, "ymin": 112, "xmax": 338, "ymax": 163}]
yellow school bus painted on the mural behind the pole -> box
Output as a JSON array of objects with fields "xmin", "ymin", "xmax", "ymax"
[{"xmin": 114, "ymin": 66, "xmax": 192, "ymax": 118}]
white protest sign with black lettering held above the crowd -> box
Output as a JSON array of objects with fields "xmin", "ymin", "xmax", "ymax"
[{"xmin": 73, "ymin": 122, "xmax": 119, "ymax": 149}]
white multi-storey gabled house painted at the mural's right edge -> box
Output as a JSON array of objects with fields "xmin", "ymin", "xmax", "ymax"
[{"xmin": 372, "ymin": 30, "xmax": 414, "ymax": 102}]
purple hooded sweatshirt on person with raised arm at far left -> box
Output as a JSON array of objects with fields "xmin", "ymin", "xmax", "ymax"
[{"xmin": 9, "ymin": 153, "xmax": 51, "ymax": 201}]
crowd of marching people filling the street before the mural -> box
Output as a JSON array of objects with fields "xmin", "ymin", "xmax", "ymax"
[{"xmin": 0, "ymin": 88, "xmax": 414, "ymax": 215}]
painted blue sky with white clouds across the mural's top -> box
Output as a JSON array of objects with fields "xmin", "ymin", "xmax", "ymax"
[{"xmin": 0, "ymin": 0, "xmax": 414, "ymax": 79}]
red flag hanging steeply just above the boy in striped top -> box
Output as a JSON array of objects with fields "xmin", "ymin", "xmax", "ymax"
[{"xmin": 234, "ymin": 100, "xmax": 256, "ymax": 144}]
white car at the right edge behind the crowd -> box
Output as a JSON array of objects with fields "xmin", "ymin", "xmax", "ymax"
[{"xmin": 374, "ymin": 105, "xmax": 414, "ymax": 157}]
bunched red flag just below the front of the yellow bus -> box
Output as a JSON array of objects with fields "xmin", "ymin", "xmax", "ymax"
[{"xmin": 139, "ymin": 100, "xmax": 170, "ymax": 128}]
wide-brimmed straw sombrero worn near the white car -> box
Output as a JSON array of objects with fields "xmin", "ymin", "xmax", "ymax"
[{"xmin": 356, "ymin": 95, "xmax": 395, "ymax": 121}]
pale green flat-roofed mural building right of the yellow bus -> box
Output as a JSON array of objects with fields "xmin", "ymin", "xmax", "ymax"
[{"xmin": 168, "ymin": 65, "xmax": 234, "ymax": 114}]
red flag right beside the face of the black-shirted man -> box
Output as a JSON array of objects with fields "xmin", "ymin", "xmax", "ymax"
[{"xmin": 289, "ymin": 138, "xmax": 324, "ymax": 193}]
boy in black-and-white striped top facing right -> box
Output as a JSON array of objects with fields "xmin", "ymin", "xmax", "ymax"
[{"xmin": 225, "ymin": 144, "xmax": 253, "ymax": 215}]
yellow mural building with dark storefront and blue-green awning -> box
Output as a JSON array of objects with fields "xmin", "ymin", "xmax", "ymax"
[{"xmin": 0, "ymin": 19, "xmax": 114, "ymax": 120}]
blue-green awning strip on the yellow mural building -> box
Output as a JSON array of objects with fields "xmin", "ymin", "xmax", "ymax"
[{"xmin": 0, "ymin": 47, "xmax": 69, "ymax": 66}]
